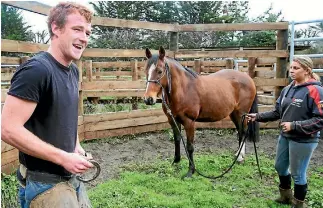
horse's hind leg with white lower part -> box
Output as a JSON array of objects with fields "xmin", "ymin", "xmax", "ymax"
[{"xmin": 230, "ymin": 110, "xmax": 246, "ymax": 162}]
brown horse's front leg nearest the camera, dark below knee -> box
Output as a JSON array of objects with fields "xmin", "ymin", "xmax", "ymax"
[{"xmin": 183, "ymin": 119, "xmax": 195, "ymax": 177}]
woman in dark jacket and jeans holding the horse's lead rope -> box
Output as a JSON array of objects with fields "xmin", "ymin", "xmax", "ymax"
[{"xmin": 247, "ymin": 56, "xmax": 323, "ymax": 208}]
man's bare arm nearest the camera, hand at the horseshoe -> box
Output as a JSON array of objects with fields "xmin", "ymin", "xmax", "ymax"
[{"xmin": 1, "ymin": 95, "xmax": 92, "ymax": 173}]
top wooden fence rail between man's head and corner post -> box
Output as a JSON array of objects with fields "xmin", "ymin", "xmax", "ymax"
[{"xmin": 92, "ymin": 17, "xmax": 176, "ymax": 31}]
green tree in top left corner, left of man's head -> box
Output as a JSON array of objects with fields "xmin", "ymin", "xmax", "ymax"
[{"xmin": 1, "ymin": 4, "xmax": 31, "ymax": 41}]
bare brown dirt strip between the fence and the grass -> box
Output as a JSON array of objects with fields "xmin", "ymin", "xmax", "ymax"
[{"xmin": 84, "ymin": 129, "xmax": 323, "ymax": 188}]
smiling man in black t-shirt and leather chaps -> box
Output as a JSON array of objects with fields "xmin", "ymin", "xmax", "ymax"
[{"xmin": 1, "ymin": 3, "xmax": 93, "ymax": 208}]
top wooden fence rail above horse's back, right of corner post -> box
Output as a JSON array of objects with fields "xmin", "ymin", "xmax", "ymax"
[{"xmin": 177, "ymin": 22, "xmax": 288, "ymax": 32}]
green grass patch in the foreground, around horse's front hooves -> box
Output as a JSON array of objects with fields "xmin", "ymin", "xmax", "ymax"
[{"xmin": 89, "ymin": 153, "xmax": 323, "ymax": 208}]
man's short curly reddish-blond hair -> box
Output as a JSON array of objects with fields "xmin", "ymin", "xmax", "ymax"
[{"xmin": 47, "ymin": 2, "xmax": 93, "ymax": 38}]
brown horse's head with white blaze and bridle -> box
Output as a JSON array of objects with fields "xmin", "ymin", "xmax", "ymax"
[{"xmin": 144, "ymin": 47, "xmax": 169, "ymax": 105}]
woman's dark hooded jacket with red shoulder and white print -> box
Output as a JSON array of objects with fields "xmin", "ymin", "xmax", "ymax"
[{"xmin": 256, "ymin": 79, "xmax": 323, "ymax": 143}]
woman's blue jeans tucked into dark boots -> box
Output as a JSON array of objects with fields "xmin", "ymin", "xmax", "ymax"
[{"xmin": 275, "ymin": 135, "xmax": 318, "ymax": 185}]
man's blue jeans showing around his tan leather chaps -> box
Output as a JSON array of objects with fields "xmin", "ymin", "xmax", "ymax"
[{"xmin": 18, "ymin": 180, "xmax": 80, "ymax": 208}]
